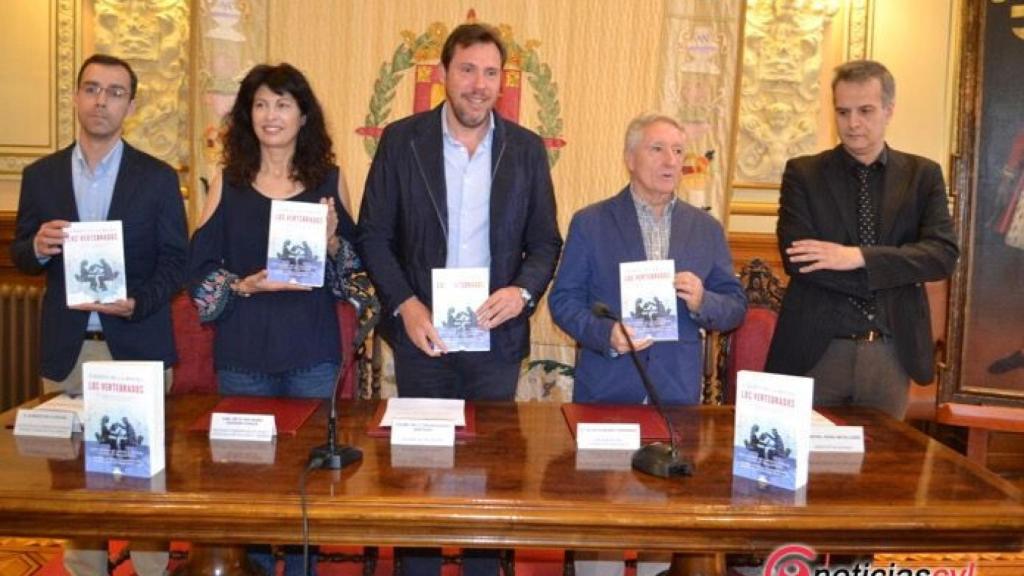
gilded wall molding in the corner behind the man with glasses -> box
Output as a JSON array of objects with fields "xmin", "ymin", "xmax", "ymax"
[{"xmin": 0, "ymin": 0, "xmax": 79, "ymax": 176}]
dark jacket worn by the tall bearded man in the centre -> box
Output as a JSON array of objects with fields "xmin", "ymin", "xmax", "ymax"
[{"xmin": 359, "ymin": 107, "xmax": 562, "ymax": 362}]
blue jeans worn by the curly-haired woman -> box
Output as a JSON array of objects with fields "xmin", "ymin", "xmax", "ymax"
[{"xmin": 217, "ymin": 362, "xmax": 338, "ymax": 398}]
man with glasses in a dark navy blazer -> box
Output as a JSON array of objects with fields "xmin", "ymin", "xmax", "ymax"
[{"xmin": 10, "ymin": 54, "xmax": 188, "ymax": 575}]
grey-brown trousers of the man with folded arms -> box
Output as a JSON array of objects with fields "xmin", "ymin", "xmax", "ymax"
[{"xmin": 807, "ymin": 338, "xmax": 910, "ymax": 420}]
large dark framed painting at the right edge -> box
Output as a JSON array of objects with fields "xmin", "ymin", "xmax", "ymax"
[{"xmin": 940, "ymin": 0, "xmax": 1024, "ymax": 407}]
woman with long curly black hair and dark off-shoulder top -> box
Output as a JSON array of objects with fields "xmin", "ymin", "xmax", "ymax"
[{"xmin": 189, "ymin": 59, "xmax": 355, "ymax": 574}]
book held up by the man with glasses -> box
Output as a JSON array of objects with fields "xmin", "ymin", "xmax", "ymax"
[{"xmin": 63, "ymin": 220, "xmax": 128, "ymax": 306}]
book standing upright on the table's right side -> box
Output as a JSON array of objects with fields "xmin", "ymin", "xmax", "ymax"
[{"xmin": 732, "ymin": 370, "xmax": 814, "ymax": 490}]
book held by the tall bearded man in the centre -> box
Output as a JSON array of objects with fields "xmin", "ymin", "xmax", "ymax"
[{"xmin": 431, "ymin": 268, "xmax": 490, "ymax": 352}]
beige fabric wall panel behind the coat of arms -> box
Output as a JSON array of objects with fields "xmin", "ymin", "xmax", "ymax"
[{"xmin": 268, "ymin": 0, "xmax": 665, "ymax": 350}]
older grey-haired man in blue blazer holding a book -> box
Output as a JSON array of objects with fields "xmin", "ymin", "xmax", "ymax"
[{"xmin": 548, "ymin": 116, "xmax": 746, "ymax": 404}]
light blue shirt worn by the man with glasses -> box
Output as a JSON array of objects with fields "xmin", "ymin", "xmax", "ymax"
[{"xmin": 71, "ymin": 139, "xmax": 125, "ymax": 332}]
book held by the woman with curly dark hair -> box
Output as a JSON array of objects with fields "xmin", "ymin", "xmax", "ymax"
[{"xmin": 266, "ymin": 200, "xmax": 328, "ymax": 288}]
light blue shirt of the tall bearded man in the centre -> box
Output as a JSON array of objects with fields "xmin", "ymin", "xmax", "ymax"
[{"xmin": 441, "ymin": 102, "xmax": 495, "ymax": 268}]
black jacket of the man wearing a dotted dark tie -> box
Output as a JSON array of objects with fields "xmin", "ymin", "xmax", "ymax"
[{"xmin": 766, "ymin": 147, "xmax": 959, "ymax": 383}]
